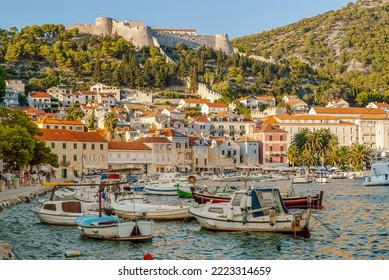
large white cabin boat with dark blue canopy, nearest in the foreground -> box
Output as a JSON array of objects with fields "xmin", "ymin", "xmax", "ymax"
[{"xmin": 189, "ymin": 188, "xmax": 311, "ymax": 236}]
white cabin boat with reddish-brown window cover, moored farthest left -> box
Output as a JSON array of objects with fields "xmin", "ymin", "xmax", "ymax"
[{"xmin": 31, "ymin": 200, "xmax": 98, "ymax": 226}]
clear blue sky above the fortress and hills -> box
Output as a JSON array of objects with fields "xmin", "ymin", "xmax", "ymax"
[{"xmin": 0, "ymin": 0, "xmax": 355, "ymax": 39}]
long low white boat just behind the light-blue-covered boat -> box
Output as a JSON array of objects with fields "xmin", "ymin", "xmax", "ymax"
[{"xmin": 111, "ymin": 201, "xmax": 191, "ymax": 221}]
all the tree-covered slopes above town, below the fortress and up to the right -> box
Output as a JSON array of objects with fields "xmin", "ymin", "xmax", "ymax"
[{"xmin": 0, "ymin": 0, "xmax": 389, "ymax": 109}]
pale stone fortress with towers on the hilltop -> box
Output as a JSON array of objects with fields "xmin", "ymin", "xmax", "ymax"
[{"xmin": 66, "ymin": 17, "xmax": 233, "ymax": 54}]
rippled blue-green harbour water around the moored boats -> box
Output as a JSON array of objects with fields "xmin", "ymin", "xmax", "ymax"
[{"xmin": 0, "ymin": 179, "xmax": 389, "ymax": 260}]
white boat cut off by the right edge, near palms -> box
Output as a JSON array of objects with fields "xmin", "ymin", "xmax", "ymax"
[{"xmin": 363, "ymin": 158, "xmax": 389, "ymax": 186}]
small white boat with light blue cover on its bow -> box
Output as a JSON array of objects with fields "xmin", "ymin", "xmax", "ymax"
[{"xmin": 76, "ymin": 215, "xmax": 154, "ymax": 241}]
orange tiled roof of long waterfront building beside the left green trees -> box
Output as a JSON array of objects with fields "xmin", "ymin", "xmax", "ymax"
[{"xmin": 35, "ymin": 129, "xmax": 107, "ymax": 142}]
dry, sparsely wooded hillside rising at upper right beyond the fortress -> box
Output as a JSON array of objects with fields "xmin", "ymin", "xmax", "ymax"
[{"xmin": 232, "ymin": 0, "xmax": 389, "ymax": 95}]
